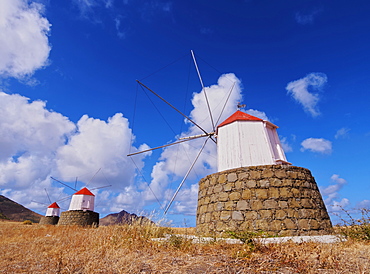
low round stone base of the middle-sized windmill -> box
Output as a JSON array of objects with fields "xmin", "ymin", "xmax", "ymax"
[{"xmin": 58, "ymin": 210, "xmax": 99, "ymax": 227}]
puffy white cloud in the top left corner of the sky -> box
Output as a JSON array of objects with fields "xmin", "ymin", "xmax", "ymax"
[{"xmin": 0, "ymin": 0, "xmax": 51, "ymax": 79}]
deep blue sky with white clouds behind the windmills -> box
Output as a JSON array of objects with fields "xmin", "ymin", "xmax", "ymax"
[{"xmin": 0, "ymin": 0, "xmax": 370, "ymax": 226}]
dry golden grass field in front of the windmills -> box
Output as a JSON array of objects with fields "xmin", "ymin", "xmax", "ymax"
[{"xmin": 0, "ymin": 222, "xmax": 370, "ymax": 273}]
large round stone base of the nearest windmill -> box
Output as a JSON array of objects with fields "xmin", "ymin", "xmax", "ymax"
[{"xmin": 197, "ymin": 165, "xmax": 332, "ymax": 236}]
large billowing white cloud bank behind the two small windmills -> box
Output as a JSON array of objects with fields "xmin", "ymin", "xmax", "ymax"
[{"xmin": 0, "ymin": 92, "xmax": 148, "ymax": 213}]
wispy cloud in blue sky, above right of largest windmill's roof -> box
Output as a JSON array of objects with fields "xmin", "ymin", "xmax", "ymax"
[{"xmin": 286, "ymin": 73, "xmax": 327, "ymax": 117}]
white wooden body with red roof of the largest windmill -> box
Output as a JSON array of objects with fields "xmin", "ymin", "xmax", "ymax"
[{"xmin": 217, "ymin": 110, "xmax": 290, "ymax": 172}]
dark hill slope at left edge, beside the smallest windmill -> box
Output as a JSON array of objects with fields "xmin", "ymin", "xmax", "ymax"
[{"xmin": 0, "ymin": 195, "xmax": 42, "ymax": 223}]
